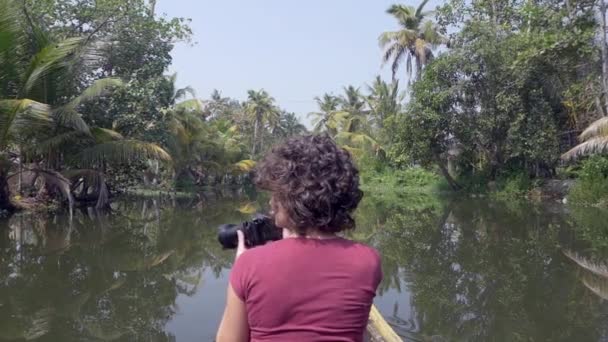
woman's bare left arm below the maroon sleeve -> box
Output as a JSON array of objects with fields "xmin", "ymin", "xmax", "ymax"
[{"xmin": 215, "ymin": 285, "xmax": 249, "ymax": 342}]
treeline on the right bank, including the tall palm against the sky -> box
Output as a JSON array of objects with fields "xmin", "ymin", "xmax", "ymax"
[{"xmin": 313, "ymin": 0, "xmax": 608, "ymax": 198}]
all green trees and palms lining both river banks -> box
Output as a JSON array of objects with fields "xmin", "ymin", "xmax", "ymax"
[{"xmin": 5, "ymin": 0, "xmax": 608, "ymax": 210}]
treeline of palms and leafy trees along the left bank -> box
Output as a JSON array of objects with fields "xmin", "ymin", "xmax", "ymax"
[{"xmin": 0, "ymin": 0, "xmax": 305, "ymax": 211}]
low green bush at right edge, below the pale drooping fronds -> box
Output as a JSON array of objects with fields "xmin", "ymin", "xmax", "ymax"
[{"xmin": 568, "ymin": 156, "xmax": 608, "ymax": 206}]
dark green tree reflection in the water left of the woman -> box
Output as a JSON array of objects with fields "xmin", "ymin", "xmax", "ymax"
[{"xmin": 0, "ymin": 191, "xmax": 253, "ymax": 341}]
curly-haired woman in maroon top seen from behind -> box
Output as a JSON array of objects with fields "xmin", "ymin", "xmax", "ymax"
[{"xmin": 217, "ymin": 136, "xmax": 382, "ymax": 342}]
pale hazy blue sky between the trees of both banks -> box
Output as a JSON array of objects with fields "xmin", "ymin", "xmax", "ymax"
[{"xmin": 157, "ymin": 0, "xmax": 436, "ymax": 123}]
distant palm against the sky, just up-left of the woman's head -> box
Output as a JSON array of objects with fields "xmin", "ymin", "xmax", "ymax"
[{"xmin": 245, "ymin": 89, "xmax": 279, "ymax": 155}]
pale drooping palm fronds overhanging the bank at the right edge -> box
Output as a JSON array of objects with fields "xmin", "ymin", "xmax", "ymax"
[{"xmin": 562, "ymin": 117, "xmax": 608, "ymax": 160}]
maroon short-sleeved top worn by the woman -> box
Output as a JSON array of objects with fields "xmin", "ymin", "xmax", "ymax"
[{"xmin": 230, "ymin": 238, "xmax": 382, "ymax": 342}]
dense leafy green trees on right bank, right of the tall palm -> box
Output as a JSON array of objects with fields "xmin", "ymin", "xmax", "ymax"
[{"xmin": 390, "ymin": 0, "xmax": 606, "ymax": 194}]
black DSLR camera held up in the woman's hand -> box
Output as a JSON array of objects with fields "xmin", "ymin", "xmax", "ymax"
[{"xmin": 217, "ymin": 214, "xmax": 283, "ymax": 249}]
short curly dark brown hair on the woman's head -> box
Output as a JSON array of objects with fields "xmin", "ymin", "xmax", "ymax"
[{"xmin": 255, "ymin": 135, "xmax": 363, "ymax": 235}]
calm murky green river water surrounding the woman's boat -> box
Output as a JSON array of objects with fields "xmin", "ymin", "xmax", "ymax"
[{"xmin": 0, "ymin": 191, "xmax": 608, "ymax": 341}]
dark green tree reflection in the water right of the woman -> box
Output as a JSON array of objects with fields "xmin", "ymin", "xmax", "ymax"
[{"xmin": 366, "ymin": 200, "xmax": 608, "ymax": 341}]
